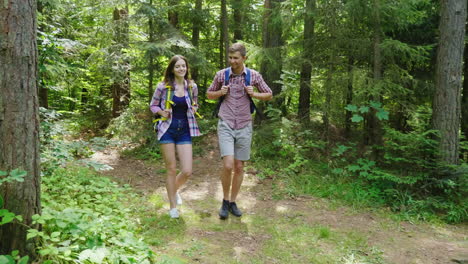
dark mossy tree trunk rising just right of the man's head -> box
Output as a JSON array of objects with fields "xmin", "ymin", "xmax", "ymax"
[{"xmin": 256, "ymin": 0, "xmax": 286, "ymax": 122}]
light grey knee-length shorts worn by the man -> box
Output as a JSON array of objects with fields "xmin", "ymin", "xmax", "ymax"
[{"xmin": 218, "ymin": 119, "xmax": 252, "ymax": 161}]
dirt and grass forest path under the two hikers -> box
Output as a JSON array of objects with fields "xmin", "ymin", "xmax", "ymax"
[{"xmin": 92, "ymin": 136, "xmax": 468, "ymax": 264}]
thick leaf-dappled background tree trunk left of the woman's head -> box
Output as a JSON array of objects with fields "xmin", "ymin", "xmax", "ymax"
[{"xmin": 111, "ymin": 7, "xmax": 130, "ymax": 117}]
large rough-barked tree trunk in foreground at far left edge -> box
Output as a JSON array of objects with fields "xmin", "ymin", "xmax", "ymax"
[{"xmin": 0, "ymin": 0, "xmax": 41, "ymax": 257}]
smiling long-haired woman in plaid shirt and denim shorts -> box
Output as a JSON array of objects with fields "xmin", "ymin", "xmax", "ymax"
[{"xmin": 150, "ymin": 55, "xmax": 200, "ymax": 218}]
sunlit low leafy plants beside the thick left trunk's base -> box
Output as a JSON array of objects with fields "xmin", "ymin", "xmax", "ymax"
[{"xmin": 28, "ymin": 167, "xmax": 153, "ymax": 263}]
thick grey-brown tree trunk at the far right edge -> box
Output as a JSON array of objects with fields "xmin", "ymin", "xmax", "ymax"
[{"xmin": 432, "ymin": 0, "xmax": 467, "ymax": 164}]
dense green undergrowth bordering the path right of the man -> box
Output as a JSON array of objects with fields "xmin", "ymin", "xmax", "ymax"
[{"xmin": 252, "ymin": 118, "xmax": 468, "ymax": 223}]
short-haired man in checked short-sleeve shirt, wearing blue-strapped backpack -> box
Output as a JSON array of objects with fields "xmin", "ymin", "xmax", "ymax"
[{"xmin": 206, "ymin": 43, "xmax": 272, "ymax": 219}]
